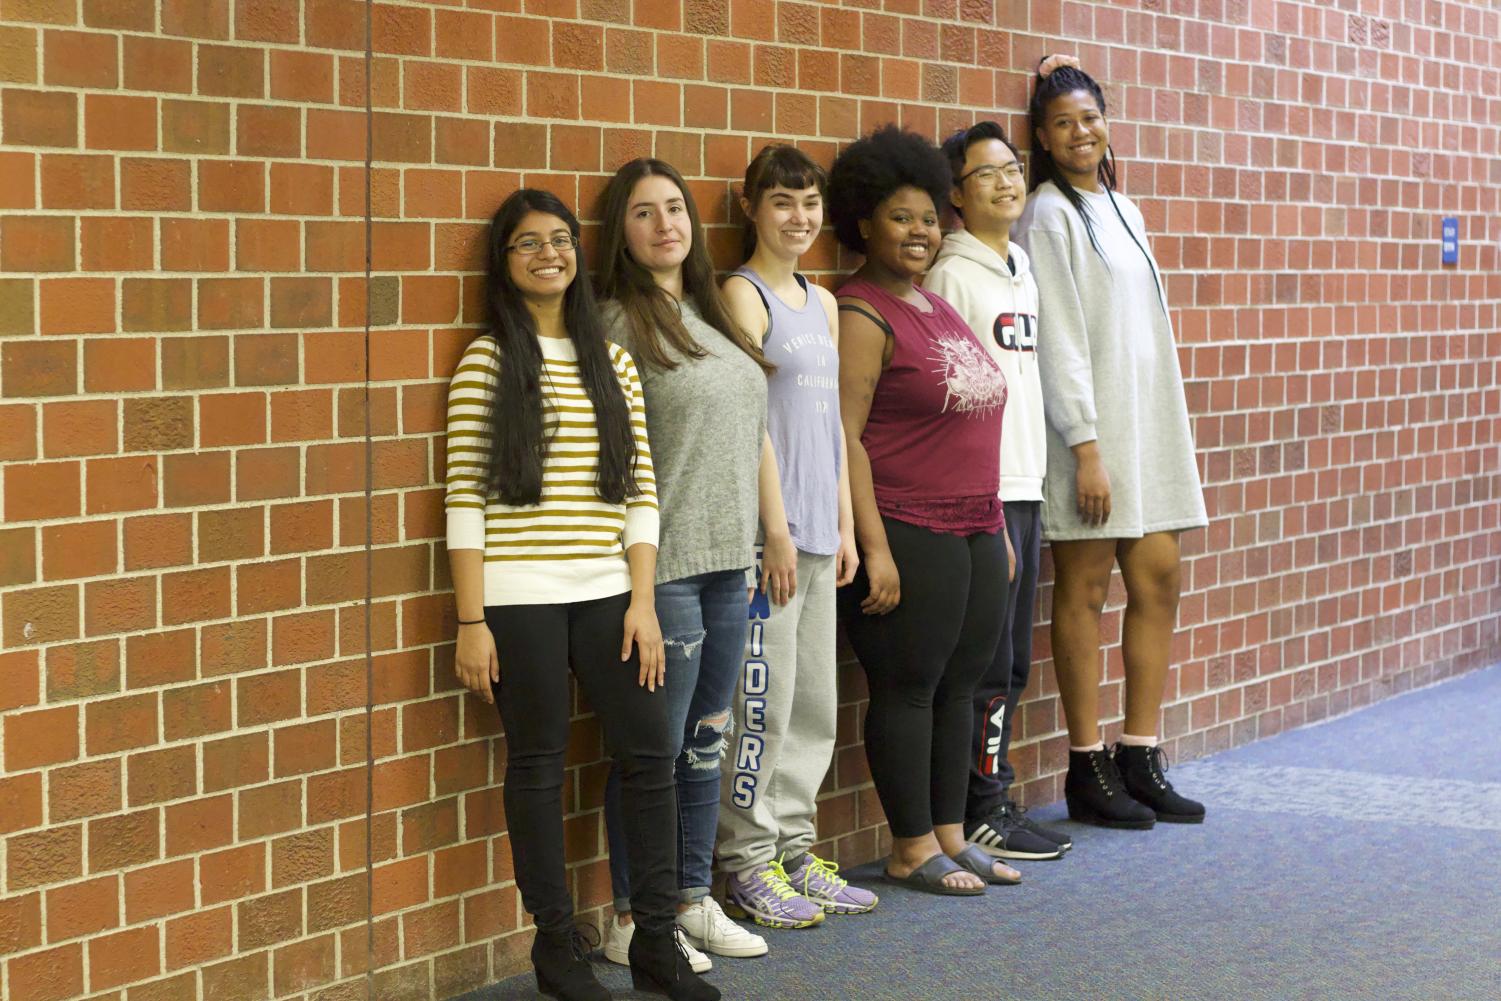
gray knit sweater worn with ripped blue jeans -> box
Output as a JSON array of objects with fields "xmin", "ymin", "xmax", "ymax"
[{"xmin": 605, "ymin": 302, "xmax": 766, "ymax": 584}]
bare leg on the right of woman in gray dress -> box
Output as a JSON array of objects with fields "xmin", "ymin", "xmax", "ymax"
[{"xmin": 1116, "ymin": 531, "xmax": 1183, "ymax": 737}]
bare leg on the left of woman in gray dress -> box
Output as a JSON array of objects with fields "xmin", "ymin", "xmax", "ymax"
[{"xmin": 1052, "ymin": 539, "xmax": 1117, "ymax": 747}]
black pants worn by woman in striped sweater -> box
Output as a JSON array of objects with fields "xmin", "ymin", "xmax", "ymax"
[{"xmin": 485, "ymin": 594, "xmax": 680, "ymax": 933}]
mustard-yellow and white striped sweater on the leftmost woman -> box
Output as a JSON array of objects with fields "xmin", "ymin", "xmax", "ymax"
[{"xmin": 444, "ymin": 335, "xmax": 657, "ymax": 605}]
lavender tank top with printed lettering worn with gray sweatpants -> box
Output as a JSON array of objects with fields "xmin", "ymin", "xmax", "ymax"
[{"xmin": 735, "ymin": 267, "xmax": 841, "ymax": 557}]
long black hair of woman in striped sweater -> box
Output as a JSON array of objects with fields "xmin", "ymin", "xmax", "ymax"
[{"xmin": 485, "ymin": 188, "xmax": 638, "ymax": 504}]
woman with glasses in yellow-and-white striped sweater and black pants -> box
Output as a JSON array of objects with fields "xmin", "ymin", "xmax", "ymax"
[{"xmin": 446, "ymin": 189, "xmax": 719, "ymax": 1001}]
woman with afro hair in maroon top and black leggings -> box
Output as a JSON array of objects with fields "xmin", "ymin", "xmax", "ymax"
[{"xmin": 829, "ymin": 126, "xmax": 1019, "ymax": 896}]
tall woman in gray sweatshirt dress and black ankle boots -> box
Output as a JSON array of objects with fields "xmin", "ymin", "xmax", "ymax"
[{"xmin": 1013, "ymin": 60, "xmax": 1207, "ymax": 827}]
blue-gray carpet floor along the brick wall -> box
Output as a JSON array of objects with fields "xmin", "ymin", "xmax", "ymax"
[{"xmin": 462, "ymin": 666, "xmax": 1501, "ymax": 1001}]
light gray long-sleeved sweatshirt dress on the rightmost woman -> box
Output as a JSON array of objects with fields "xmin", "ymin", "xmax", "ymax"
[{"xmin": 1012, "ymin": 182, "xmax": 1208, "ymax": 540}]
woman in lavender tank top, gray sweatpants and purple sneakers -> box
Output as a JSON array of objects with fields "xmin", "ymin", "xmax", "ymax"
[{"xmin": 716, "ymin": 146, "xmax": 877, "ymax": 927}]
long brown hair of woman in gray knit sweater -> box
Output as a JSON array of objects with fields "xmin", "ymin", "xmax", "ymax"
[{"xmin": 599, "ymin": 158, "xmax": 775, "ymax": 372}]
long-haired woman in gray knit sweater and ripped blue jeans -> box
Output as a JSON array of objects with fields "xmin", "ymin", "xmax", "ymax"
[{"xmin": 599, "ymin": 159, "xmax": 769, "ymax": 998}]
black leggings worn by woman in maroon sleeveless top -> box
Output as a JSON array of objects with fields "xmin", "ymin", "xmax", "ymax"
[{"xmin": 841, "ymin": 516, "xmax": 1006, "ymax": 837}]
